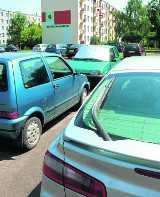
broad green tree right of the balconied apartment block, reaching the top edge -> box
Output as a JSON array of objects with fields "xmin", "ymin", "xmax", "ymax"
[{"xmin": 114, "ymin": 0, "xmax": 150, "ymax": 42}]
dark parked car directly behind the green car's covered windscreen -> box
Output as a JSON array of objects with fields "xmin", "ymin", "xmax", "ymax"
[{"xmin": 65, "ymin": 44, "xmax": 86, "ymax": 58}]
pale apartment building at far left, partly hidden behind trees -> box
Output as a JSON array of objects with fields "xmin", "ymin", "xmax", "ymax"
[{"xmin": 0, "ymin": 8, "xmax": 41, "ymax": 45}]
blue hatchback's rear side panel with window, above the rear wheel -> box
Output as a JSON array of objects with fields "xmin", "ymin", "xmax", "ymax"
[{"xmin": 15, "ymin": 56, "xmax": 55, "ymax": 122}]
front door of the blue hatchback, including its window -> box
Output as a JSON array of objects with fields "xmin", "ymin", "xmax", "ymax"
[{"xmin": 46, "ymin": 56, "xmax": 79, "ymax": 116}]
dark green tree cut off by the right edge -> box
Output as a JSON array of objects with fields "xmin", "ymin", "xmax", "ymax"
[{"xmin": 147, "ymin": 0, "xmax": 160, "ymax": 47}]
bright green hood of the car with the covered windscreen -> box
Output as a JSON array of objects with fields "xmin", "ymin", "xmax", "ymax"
[{"xmin": 69, "ymin": 60, "xmax": 110, "ymax": 73}]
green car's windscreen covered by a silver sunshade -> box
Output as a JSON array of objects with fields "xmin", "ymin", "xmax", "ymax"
[{"xmin": 74, "ymin": 46, "xmax": 110, "ymax": 61}]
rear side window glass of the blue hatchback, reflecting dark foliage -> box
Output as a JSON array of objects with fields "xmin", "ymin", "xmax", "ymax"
[{"xmin": 20, "ymin": 58, "xmax": 49, "ymax": 88}]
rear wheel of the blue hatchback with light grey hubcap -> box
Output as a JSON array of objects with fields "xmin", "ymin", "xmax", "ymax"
[{"xmin": 22, "ymin": 117, "xmax": 42, "ymax": 150}]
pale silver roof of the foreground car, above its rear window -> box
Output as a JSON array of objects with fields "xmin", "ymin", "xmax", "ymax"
[{"xmin": 111, "ymin": 56, "xmax": 160, "ymax": 73}]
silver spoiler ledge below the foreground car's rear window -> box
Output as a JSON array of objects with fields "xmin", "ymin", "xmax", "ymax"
[{"xmin": 63, "ymin": 119, "xmax": 160, "ymax": 169}]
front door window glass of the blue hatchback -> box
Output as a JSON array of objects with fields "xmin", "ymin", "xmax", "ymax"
[{"xmin": 46, "ymin": 57, "xmax": 72, "ymax": 79}]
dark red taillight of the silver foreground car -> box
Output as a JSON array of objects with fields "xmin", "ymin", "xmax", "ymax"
[{"xmin": 43, "ymin": 151, "xmax": 107, "ymax": 197}]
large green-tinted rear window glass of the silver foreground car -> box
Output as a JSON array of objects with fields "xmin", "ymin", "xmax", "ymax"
[{"xmin": 98, "ymin": 75, "xmax": 160, "ymax": 143}]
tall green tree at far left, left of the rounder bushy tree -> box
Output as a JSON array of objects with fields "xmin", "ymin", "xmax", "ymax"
[{"xmin": 7, "ymin": 12, "xmax": 27, "ymax": 47}]
